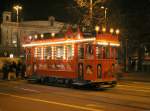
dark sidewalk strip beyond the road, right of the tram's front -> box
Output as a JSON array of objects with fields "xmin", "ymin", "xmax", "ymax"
[{"xmin": 119, "ymin": 72, "xmax": 150, "ymax": 82}]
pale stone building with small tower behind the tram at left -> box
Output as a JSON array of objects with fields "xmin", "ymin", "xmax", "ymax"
[{"xmin": 0, "ymin": 11, "xmax": 66, "ymax": 56}]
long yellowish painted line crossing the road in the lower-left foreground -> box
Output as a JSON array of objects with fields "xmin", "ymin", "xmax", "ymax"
[{"xmin": 0, "ymin": 93, "xmax": 103, "ymax": 111}]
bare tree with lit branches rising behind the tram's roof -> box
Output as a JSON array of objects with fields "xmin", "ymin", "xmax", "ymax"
[{"xmin": 75, "ymin": 0, "xmax": 106, "ymax": 26}]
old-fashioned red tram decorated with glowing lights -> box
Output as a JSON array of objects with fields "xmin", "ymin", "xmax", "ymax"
[{"xmin": 23, "ymin": 27, "xmax": 120, "ymax": 87}]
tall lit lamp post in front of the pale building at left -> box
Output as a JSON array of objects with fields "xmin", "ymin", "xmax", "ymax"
[{"xmin": 13, "ymin": 5, "xmax": 22, "ymax": 56}]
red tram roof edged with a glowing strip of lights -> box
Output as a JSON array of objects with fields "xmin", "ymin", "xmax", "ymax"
[{"xmin": 23, "ymin": 34, "xmax": 120, "ymax": 47}]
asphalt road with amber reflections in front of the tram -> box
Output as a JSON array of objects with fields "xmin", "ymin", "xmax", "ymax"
[{"xmin": 0, "ymin": 81, "xmax": 150, "ymax": 111}]
